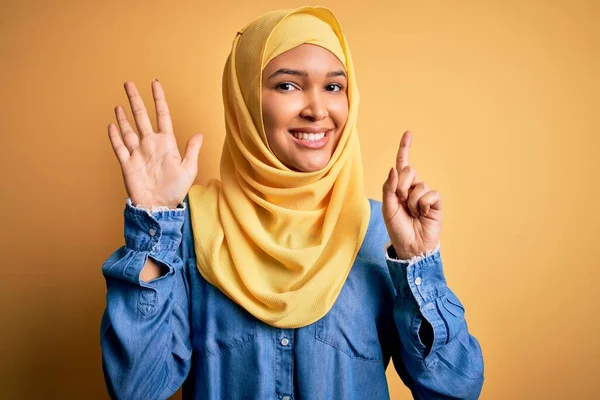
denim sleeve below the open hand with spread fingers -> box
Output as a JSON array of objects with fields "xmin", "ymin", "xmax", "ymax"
[{"xmin": 100, "ymin": 199, "xmax": 191, "ymax": 399}]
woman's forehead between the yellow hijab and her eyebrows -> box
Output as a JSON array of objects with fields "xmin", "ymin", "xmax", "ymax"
[{"xmin": 264, "ymin": 43, "xmax": 345, "ymax": 73}]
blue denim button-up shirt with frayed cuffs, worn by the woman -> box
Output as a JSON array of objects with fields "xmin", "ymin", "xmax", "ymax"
[{"xmin": 100, "ymin": 197, "xmax": 483, "ymax": 400}]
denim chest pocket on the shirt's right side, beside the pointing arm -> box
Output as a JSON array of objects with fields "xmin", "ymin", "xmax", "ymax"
[{"xmin": 315, "ymin": 266, "xmax": 382, "ymax": 362}]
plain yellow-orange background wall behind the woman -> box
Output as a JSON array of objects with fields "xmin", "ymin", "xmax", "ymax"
[{"xmin": 0, "ymin": 0, "xmax": 600, "ymax": 400}]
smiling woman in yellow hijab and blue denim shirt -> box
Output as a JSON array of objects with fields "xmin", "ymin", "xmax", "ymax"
[{"xmin": 101, "ymin": 7, "xmax": 483, "ymax": 400}]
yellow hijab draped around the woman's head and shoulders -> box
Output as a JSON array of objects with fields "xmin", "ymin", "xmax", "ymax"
[{"xmin": 188, "ymin": 7, "xmax": 370, "ymax": 328}]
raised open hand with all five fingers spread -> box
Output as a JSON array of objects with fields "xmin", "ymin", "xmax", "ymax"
[{"xmin": 108, "ymin": 79, "xmax": 203, "ymax": 208}]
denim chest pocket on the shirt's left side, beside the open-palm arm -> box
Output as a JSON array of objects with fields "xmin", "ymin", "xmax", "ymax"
[{"xmin": 188, "ymin": 259, "xmax": 256, "ymax": 356}]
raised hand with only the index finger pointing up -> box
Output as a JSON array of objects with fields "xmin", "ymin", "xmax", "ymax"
[{"xmin": 382, "ymin": 131, "xmax": 442, "ymax": 259}]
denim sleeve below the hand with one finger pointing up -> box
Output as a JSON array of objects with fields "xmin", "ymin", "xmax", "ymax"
[{"xmin": 386, "ymin": 245, "xmax": 484, "ymax": 399}]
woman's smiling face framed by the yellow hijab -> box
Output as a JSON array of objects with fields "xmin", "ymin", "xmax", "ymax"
[{"xmin": 262, "ymin": 44, "xmax": 348, "ymax": 172}]
